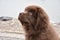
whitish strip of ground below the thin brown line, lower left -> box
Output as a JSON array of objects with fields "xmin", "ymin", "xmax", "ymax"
[{"xmin": 0, "ymin": 32, "xmax": 25, "ymax": 40}]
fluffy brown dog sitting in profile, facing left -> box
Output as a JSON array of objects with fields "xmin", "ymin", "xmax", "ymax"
[{"xmin": 18, "ymin": 5, "xmax": 59, "ymax": 40}]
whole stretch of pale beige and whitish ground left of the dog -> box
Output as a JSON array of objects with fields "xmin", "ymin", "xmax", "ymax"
[{"xmin": 0, "ymin": 18, "xmax": 24, "ymax": 40}]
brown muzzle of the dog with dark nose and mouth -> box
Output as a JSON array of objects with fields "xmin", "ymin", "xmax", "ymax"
[{"xmin": 18, "ymin": 12, "xmax": 32, "ymax": 24}]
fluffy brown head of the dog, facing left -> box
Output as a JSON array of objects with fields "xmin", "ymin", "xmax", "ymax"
[{"xmin": 18, "ymin": 6, "xmax": 49, "ymax": 28}]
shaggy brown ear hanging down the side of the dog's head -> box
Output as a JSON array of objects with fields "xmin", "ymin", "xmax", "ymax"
[{"xmin": 35, "ymin": 7, "xmax": 49, "ymax": 28}]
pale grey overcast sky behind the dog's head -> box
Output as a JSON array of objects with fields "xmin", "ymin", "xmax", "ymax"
[{"xmin": 0, "ymin": 0, "xmax": 60, "ymax": 22}]
